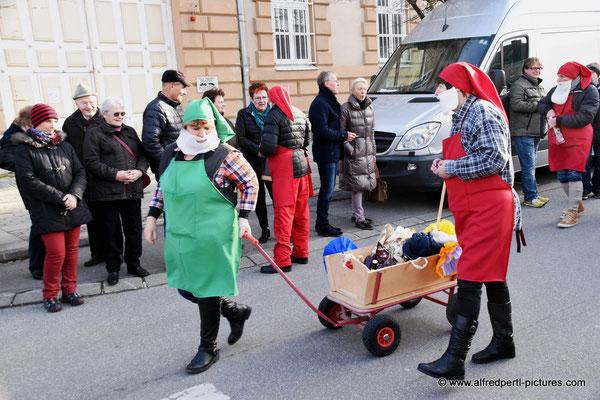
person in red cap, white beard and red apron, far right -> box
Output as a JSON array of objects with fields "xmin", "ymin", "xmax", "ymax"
[{"xmin": 537, "ymin": 61, "xmax": 598, "ymax": 228}]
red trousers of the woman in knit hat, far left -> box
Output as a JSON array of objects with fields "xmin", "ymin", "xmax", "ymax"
[{"xmin": 42, "ymin": 226, "xmax": 81, "ymax": 299}]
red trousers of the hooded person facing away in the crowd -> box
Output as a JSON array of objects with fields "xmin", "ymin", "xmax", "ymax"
[{"xmin": 273, "ymin": 175, "xmax": 310, "ymax": 267}]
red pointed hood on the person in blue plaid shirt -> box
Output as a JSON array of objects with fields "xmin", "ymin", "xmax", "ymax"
[{"xmin": 440, "ymin": 62, "xmax": 508, "ymax": 121}]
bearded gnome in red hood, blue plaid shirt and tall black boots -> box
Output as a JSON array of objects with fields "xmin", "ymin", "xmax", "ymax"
[{"xmin": 418, "ymin": 62, "xmax": 521, "ymax": 379}]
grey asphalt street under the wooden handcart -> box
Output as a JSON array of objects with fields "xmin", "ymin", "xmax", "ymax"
[{"xmin": 0, "ymin": 170, "xmax": 600, "ymax": 400}]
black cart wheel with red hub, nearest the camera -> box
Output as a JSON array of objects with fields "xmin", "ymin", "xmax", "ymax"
[{"xmin": 363, "ymin": 314, "xmax": 401, "ymax": 357}]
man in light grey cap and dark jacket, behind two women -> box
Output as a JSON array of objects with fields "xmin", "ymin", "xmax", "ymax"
[{"xmin": 63, "ymin": 84, "xmax": 104, "ymax": 267}]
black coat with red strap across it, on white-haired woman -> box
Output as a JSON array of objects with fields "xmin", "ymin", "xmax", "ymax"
[{"xmin": 83, "ymin": 123, "xmax": 148, "ymax": 201}]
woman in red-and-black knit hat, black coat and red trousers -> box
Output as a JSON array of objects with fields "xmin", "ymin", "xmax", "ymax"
[{"xmin": 15, "ymin": 104, "xmax": 92, "ymax": 312}]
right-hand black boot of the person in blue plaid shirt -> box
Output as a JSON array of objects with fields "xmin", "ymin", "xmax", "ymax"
[{"xmin": 471, "ymin": 303, "xmax": 515, "ymax": 364}]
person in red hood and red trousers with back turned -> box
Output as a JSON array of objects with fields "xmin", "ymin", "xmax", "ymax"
[{"xmin": 259, "ymin": 86, "xmax": 313, "ymax": 274}]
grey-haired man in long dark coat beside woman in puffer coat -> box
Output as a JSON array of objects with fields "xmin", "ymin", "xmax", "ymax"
[{"xmin": 308, "ymin": 71, "xmax": 356, "ymax": 236}]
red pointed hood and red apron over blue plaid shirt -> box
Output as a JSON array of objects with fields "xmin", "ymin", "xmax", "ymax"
[{"xmin": 440, "ymin": 62, "xmax": 514, "ymax": 282}]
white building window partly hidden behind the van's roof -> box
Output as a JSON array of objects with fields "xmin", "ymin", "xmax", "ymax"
[{"xmin": 377, "ymin": 0, "xmax": 408, "ymax": 64}]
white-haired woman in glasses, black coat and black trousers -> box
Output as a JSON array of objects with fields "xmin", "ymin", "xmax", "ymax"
[{"xmin": 83, "ymin": 97, "xmax": 148, "ymax": 285}]
